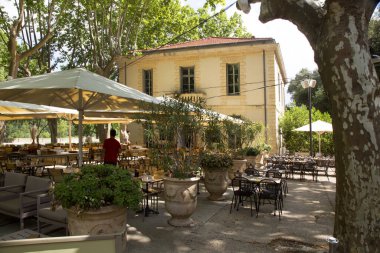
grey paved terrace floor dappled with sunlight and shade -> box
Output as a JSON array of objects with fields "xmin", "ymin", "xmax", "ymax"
[{"xmin": 0, "ymin": 177, "xmax": 335, "ymax": 253}]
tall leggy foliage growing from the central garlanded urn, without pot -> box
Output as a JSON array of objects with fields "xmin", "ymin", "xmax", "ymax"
[{"xmin": 139, "ymin": 96, "xmax": 205, "ymax": 178}]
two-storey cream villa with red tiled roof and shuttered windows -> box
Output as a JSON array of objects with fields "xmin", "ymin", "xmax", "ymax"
[{"xmin": 118, "ymin": 37, "xmax": 287, "ymax": 152}]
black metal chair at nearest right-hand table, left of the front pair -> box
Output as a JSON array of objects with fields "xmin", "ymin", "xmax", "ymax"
[{"xmin": 230, "ymin": 177, "xmax": 257, "ymax": 216}]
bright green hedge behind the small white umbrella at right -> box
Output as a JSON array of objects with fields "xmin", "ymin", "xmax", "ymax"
[{"xmin": 280, "ymin": 105, "xmax": 334, "ymax": 155}]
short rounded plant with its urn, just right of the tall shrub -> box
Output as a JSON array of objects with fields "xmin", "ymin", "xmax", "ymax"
[{"xmin": 200, "ymin": 153, "xmax": 233, "ymax": 200}]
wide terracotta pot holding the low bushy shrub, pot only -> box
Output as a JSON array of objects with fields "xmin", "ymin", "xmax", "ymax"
[{"xmin": 66, "ymin": 206, "xmax": 127, "ymax": 235}]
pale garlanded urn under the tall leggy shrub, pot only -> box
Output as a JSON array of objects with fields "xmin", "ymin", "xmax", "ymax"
[{"xmin": 164, "ymin": 177, "xmax": 199, "ymax": 227}]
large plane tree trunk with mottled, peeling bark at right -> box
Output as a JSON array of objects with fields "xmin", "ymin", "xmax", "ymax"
[{"xmin": 239, "ymin": 0, "xmax": 380, "ymax": 252}]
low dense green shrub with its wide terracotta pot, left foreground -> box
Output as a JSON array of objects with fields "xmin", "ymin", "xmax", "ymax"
[{"xmin": 53, "ymin": 165, "xmax": 142, "ymax": 235}]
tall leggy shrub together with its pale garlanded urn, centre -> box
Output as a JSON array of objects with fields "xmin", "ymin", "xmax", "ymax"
[{"xmin": 141, "ymin": 96, "xmax": 204, "ymax": 227}]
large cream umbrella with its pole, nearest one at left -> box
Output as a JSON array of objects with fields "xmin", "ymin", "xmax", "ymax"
[{"xmin": 0, "ymin": 68, "xmax": 159, "ymax": 166}]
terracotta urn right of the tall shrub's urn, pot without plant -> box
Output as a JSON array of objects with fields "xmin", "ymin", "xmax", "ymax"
[{"xmin": 205, "ymin": 170, "xmax": 230, "ymax": 201}]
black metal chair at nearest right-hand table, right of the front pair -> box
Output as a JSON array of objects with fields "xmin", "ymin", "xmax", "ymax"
[{"xmin": 256, "ymin": 179, "xmax": 283, "ymax": 220}]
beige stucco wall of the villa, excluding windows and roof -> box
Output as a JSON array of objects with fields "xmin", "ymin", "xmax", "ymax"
[{"xmin": 119, "ymin": 44, "xmax": 286, "ymax": 152}]
